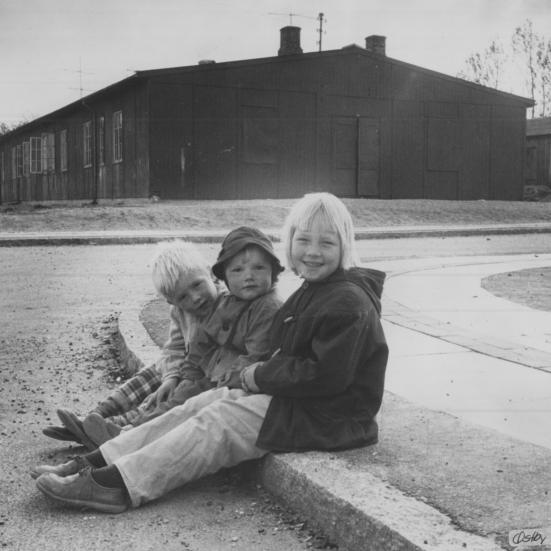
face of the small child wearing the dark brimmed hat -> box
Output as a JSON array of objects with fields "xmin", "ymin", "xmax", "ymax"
[{"xmin": 224, "ymin": 247, "xmax": 272, "ymax": 300}]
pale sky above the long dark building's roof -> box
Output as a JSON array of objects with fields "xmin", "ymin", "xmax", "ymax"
[{"xmin": 0, "ymin": 0, "xmax": 551, "ymax": 124}]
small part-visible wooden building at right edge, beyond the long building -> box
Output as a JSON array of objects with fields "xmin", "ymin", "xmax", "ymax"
[{"xmin": 526, "ymin": 117, "xmax": 551, "ymax": 194}]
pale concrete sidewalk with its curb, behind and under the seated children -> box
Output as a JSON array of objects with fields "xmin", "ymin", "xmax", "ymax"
[{"xmin": 119, "ymin": 255, "xmax": 551, "ymax": 551}]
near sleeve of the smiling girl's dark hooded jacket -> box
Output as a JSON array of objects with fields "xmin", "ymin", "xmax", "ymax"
[{"xmin": 254, "ymin": 308, "xmax": 380, "ymax": 397}]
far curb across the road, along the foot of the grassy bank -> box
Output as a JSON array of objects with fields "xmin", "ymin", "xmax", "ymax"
[{"xmin": 0, "ymin": 223, "xmax": 551, "ymax": 247}]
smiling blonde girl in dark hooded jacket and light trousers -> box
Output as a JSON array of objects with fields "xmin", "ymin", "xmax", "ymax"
[{"xmin": 33, "ymin": 193, "xmax": 388, "ymax": 512}]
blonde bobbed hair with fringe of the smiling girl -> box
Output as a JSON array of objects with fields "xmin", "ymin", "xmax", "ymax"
[{"xmin": 282, "ymin": 192, "xmax": 359, "ymax": 273}]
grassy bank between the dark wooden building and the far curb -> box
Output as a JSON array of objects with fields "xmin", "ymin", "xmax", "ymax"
[{"xmin": 0, "ymin": 199, "xmax": 551, "ymax": 232}]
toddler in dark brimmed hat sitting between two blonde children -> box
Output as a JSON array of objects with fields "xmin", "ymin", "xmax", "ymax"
[{"xmin": 85, "ymin": 226, "xmax": 283, "ymax": 440}]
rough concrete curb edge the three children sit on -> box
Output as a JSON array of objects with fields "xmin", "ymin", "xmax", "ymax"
[{"xmin": 117, "ymin": 303, "xmax": 503, "ymax": 551}]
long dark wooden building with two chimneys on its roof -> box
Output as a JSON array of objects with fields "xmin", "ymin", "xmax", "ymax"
[{"xmin": 0, "ymin": 27, "xmax": 531, "ymax": 202}]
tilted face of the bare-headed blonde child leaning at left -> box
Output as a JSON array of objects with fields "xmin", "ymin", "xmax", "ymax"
[{"xmin": 165, "ymin": 269, "xmax": 218, "ymax": 319}]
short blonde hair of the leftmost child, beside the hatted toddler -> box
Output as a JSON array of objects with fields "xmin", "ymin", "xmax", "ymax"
[{"xmin": 152, "ymin": 239, "xmax": 214, "ymax": 297}]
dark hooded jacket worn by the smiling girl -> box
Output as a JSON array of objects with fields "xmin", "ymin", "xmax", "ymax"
[{"xmin": 254, "ymin": 268, "xmax": 388, "ymax": 451}]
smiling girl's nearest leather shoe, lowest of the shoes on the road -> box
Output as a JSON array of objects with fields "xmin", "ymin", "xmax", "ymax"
[{"xmin": 36, "ymin": 468, "xmax": 128, "ymax": 513}]
